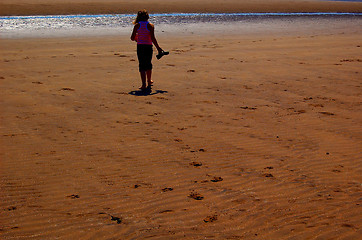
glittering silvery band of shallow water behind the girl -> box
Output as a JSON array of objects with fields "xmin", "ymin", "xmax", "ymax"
[{"xmin": 0, "ymin": 13, "xmax": 362, "ymax": 38}]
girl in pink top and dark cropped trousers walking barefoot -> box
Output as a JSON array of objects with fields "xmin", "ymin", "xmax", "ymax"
[{"xmin": 131, "ymin": 10, "xmax": 163, "ymax": 90}]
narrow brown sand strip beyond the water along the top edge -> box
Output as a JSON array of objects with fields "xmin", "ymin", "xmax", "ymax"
[{"xmin": 0, "ymin": 0, "xmax": 362, "ymax": 16}]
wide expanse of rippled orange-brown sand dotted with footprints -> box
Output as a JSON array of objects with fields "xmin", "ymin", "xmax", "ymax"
[{"xmin": 0, "ymin": 0, "xmax": 362, "ymax": 239}]
